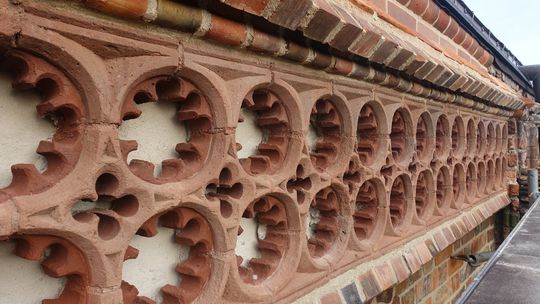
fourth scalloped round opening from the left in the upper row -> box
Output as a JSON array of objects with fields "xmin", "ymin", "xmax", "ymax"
[{"xmin": 307, "ymin": 99, "xmax": 343, "ymax": 170}]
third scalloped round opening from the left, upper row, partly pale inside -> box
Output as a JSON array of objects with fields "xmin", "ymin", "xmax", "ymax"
[{"xmin": 235, "ymin": 89, "xmax": 291, "ymax": 174}]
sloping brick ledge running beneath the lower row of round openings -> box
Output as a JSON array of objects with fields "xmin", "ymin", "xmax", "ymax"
[{"xmin": 286, "ymin": 191, "xmax": 510, "ymax": 304}]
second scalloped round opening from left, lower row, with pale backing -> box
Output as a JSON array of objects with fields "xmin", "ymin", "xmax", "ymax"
[{"xmin": 122, "ymin": 207, "xmax": 213, "ymax": 303}]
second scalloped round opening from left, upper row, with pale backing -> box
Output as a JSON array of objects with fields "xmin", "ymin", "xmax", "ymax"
[{"xmin": 119, "ymin": 76, "xmax": 215, "ymax": 183}]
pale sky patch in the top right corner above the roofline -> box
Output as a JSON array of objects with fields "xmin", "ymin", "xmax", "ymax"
[{"xmin": 463, "ymin": 0, "xmax": 540, "ymax": 65}]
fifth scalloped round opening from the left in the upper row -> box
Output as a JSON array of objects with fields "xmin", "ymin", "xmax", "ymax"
[{"xmin": 356, "ymin": 104, "xmax": 382, "ymax": 166}]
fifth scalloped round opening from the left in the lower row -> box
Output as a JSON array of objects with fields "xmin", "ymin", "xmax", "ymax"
[{"xmin": 353, "ymin": 180, "xmax": 381, "ymax": 241}]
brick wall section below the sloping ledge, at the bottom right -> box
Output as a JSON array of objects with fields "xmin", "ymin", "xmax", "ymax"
[{"xmin": 364, "ymin": 215, "xmax": 497, "ymax": 304}]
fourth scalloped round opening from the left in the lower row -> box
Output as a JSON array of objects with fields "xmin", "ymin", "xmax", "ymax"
[{"xmin": 306, "ymin": 187, "xmax": 340, "ymax": 258}]
